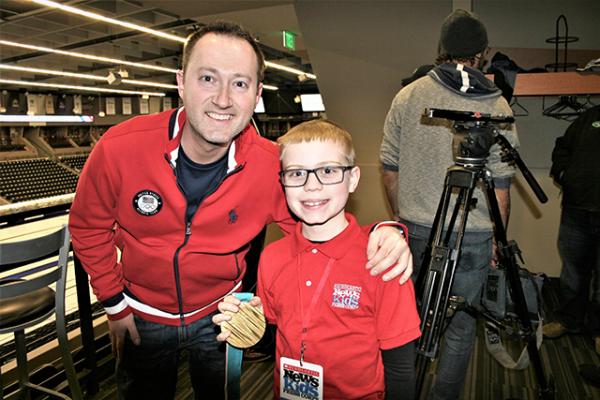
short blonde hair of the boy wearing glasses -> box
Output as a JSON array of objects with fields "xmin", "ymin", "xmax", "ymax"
[{"xmin": 277, "ymin": 119, "xmax": 355, "ymax": 165}]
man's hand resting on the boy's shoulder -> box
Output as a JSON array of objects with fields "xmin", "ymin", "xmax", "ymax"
[{"xmin": 367, "ymin": 226, "xmax": 413, "ymax": 284}]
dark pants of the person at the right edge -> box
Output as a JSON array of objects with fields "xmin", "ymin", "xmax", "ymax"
[{"xmin": 556, "ymin": 207, "xmax": 600, "ymax": 336}]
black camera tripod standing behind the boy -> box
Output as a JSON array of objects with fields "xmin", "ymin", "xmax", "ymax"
[{"xmin": 416, "ymin": 109, "xmax": 554, "ymax": 399}]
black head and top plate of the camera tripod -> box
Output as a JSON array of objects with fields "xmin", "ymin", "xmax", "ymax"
[{"xmin": 425, "ymin": 108, "xmax": 515, "ymax": 168}]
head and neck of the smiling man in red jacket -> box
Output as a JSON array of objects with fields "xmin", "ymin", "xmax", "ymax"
[{"xmin": 177, "ymin": 33, "xmax": 264, "ymax": 163}]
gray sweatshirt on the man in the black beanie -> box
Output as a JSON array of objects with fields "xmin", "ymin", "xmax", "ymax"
[{"xmin": 380, "ymin": 67, "xmax": 518, "ymax": 232}]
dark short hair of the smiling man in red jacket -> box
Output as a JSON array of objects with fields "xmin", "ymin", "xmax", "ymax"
[{"xmin": 181, "ymin": 21, "xmax": 265, "ymax": 83}]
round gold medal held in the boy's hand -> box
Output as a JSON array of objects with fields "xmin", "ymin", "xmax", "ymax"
[{"xmin": 221, "ymin": 302, "xmax": 267, "ymax": 349}]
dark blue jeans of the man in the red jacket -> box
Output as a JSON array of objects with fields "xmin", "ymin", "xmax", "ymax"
[{"xmin": 116, "ymin": 314, "xmax": 225, "ymax": 400}]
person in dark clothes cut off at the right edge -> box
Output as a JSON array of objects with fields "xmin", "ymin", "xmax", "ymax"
[{"xmin": 542, "ymin": 106, "xmax": 600, "ymax": 385}]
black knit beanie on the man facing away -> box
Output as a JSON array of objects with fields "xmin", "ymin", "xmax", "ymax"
[{"xmin": 440, "ymin": 10, "xmax": 488, "ymax": 58}]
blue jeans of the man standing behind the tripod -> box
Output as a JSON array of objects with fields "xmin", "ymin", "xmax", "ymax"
[{"xmin": 403, "ymin": 221, "xmax": 492, "ymax": 400}]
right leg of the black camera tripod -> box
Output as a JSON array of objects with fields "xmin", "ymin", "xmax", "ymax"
[{"xmin": 484, "ymin": 176, "xmax": 554, "ymax": 399}]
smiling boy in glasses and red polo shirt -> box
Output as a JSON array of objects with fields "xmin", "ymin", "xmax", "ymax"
[{"xmin": 213, "ymin": 120, "xmax": 420, "ymax": 399}]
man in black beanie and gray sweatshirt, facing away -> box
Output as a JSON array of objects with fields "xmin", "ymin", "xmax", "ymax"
[{"xmin": 380, "ymin": 10, "xmax": 518, "ymax": 399}]
